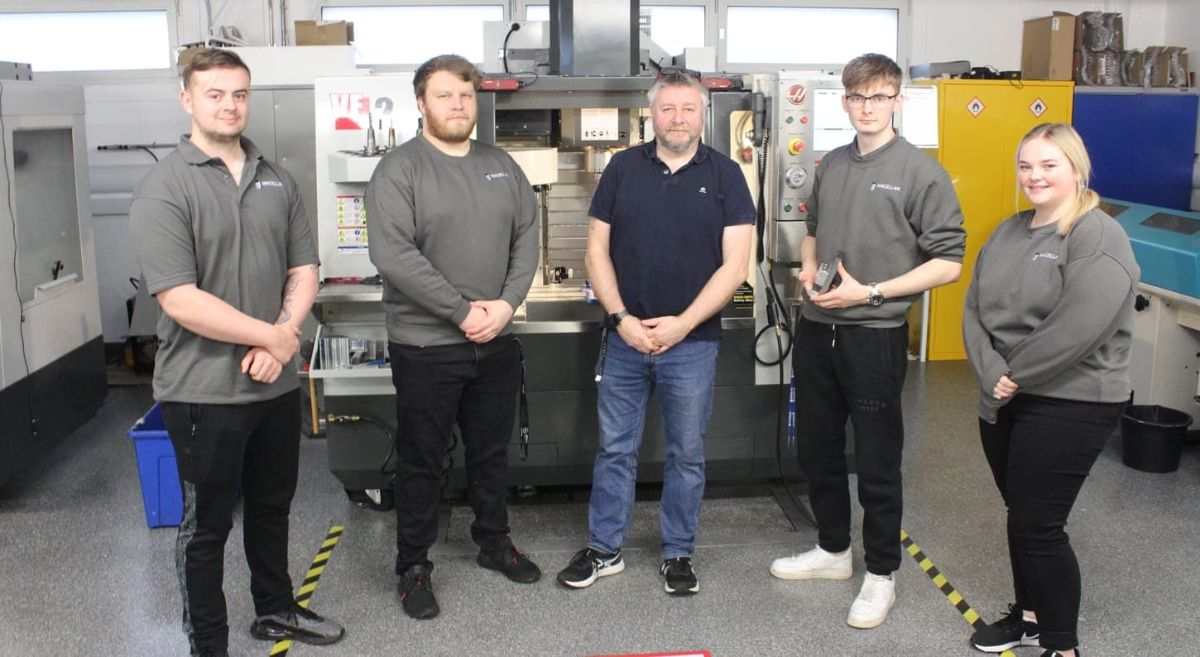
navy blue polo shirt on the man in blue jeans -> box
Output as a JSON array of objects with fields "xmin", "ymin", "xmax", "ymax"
[{"xmin": 588, "ymin": 141, "xmax": 755, "ymax": 339}]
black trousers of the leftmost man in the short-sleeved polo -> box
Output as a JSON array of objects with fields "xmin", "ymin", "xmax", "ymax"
[{"xmin": 162, "ymin": 391, "xmax": 300, "ymax": 651}]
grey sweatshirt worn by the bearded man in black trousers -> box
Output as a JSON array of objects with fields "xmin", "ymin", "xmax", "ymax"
[{"xmin": 366, "ymin": 135, "xmax": 538, "ymax": 346}]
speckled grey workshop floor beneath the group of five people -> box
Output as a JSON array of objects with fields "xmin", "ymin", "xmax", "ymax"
[{"xmin": 0, "ymin": 363, "xmax": 1200, "ymax": 657}]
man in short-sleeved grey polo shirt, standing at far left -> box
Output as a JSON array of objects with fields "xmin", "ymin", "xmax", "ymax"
[{"xmin": 130, "ymin": 49, "xmax": 344, "ymax": 657}]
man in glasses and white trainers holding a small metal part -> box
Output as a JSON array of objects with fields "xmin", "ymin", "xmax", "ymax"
[{"xmin": 770, "ymin": 54, "xmax": 966, "ymax": 628}]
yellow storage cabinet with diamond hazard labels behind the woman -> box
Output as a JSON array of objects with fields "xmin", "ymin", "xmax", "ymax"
[{"xmin": 926, "ymin": 80, "xmax": 1074, "ymax": 361}]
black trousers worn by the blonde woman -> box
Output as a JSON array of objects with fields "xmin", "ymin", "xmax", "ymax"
[{"xmin": 979, "ymin": 394, "xmax": 1124, "ymax": 650}]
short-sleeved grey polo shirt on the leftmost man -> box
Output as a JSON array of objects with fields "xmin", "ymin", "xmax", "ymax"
[{"xmin": 130, "ymin": 135, "xmax": 318, "ymax": 404}]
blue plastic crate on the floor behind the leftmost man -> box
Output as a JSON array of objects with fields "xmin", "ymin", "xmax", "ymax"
[{"xmin": 130, "ymin": 404, "xmax": 184, "ymax": 528}]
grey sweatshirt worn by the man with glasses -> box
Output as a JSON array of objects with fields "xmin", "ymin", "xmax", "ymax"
[{"xmin": 803, "ymin": 137, "xmax": 966, "ymax": 329}]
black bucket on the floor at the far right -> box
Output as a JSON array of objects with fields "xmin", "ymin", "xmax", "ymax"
[{"xmin": 1121, "ymin": 405, "xmax": 1192, "ymax": 472}]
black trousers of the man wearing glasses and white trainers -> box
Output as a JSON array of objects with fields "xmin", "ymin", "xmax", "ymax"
[{"xmin": 792, "ymin": 319, "xmax": 908, "ymax": 574}]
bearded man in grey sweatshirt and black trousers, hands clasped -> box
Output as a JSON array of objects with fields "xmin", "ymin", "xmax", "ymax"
[{"xmin": 366, "ymin": 55, "xmax": 541, "ymax": 619}]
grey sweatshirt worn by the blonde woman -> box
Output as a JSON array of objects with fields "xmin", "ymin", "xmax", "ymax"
[{"xmin": 962, "ymin": 210, "xmax": 1140, "ymax": 422}]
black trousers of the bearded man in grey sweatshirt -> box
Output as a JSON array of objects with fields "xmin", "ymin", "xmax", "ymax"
[{"xmin": 388, "ymin": 336, "xmax": 521, "ymax": 574}]
